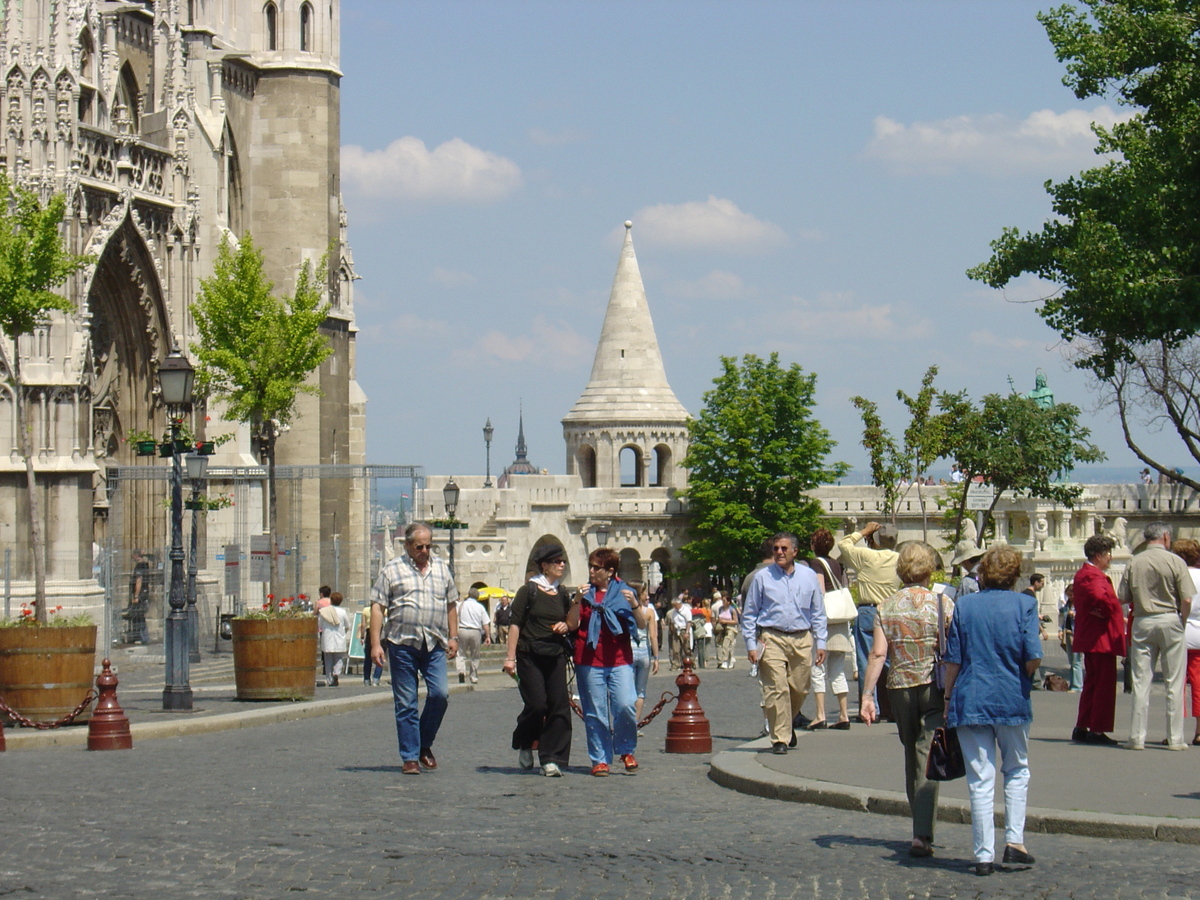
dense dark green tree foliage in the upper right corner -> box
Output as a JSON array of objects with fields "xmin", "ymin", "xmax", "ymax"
[{"xmin": 967, "ymin": 0, "xmax": 1200, "ymax": 378}]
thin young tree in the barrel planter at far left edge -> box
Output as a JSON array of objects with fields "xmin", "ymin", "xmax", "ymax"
[{"xmin": 0, "ymin": 174, "xmax": 91, "ymax": 623}]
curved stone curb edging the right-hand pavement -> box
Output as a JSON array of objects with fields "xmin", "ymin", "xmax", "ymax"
[{"xmin": 708, "ymin": 739, "xmax": 1200, "ymax": 845}]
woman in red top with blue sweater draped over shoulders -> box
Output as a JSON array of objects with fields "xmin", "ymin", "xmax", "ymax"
[{"xmin": 566, "ymin": 547, "xmax": 646, "ymax": 775}]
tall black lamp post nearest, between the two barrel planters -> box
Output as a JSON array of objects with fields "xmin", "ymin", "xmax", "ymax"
[{"xmin": 158, "ymin": 350, "xmax": 196, "ymax": 709}]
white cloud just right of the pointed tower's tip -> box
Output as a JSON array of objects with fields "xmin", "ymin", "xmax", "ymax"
[{"xmin": 618, "ymin": 196, "xmax": 787, "ymax": 252}]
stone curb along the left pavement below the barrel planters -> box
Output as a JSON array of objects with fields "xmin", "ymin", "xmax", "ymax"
[{"xmin": 5, "ymin": 679, "xmax": 508, "ymax": 751}]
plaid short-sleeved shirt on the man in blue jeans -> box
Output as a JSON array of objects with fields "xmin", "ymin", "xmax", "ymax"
[{"xmin": 371, "ymin": 554, "xmax": 458, "ymax": 648}]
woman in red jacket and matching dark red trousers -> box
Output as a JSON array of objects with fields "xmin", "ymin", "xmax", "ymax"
[{"xmin": 1070, "ymin": 534, "xmax": 1126, "ymax": 745}]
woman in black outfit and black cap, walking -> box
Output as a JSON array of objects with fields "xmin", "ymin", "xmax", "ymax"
[{"xmin": 504, "ymin": 544, "xmax": 571, "ymax": 778}]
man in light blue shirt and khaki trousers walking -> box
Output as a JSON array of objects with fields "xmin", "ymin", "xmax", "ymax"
[{"xmin": 742, "ymin": 532, "xmax": 827, "ymax": 755}]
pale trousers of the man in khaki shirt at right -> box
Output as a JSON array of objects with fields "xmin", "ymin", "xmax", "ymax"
[{"xmin": 1129, "ymin": 612, "xmax": 1188, "ymax": 745}]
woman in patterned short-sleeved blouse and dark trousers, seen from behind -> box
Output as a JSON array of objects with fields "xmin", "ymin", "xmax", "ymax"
[{"xmin": 862, "ymin": 541, "xmax": 954, "ymax": 857}]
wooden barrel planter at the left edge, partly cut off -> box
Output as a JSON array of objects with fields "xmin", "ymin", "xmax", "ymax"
[{"xmin": 0, "ymin": 625, "xmax": 96, "ymax": 725}]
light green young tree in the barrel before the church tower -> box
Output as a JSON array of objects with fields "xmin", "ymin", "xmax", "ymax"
[{"xmin": 191, "ymin": 233, "xmax": 332, "ymax": 608}]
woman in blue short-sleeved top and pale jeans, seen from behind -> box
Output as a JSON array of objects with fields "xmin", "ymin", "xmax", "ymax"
[{"xmin": 946, "ymin": 545, "xmax": 1041, "ymax": 875}]
